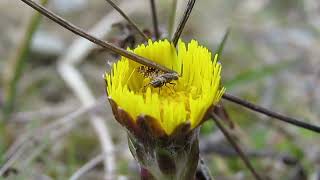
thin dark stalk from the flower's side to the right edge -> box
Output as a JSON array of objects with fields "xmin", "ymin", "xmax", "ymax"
[{"xmin": 222, "ymin": 93, "xmax": 320, "ymax": 133}]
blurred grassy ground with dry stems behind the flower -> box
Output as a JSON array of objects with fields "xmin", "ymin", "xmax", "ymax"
[{"xmin": 0, "ymin": 0, "xmax": 320, "ymax": 180}]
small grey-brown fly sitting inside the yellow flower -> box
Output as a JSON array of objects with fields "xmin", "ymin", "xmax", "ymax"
[{"xmin": 138, "ymin": 66, "xmax": 179, "ymax": 88}]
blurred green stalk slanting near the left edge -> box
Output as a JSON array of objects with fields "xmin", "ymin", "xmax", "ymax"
[{"xmin": 3, "ymin": 0, "xmax": 48, "ymax": 119}]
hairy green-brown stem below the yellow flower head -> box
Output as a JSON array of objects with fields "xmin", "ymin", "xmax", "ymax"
[{"xmin": 128, "ymin": 129, "xmax": 199, "ymax": 180}]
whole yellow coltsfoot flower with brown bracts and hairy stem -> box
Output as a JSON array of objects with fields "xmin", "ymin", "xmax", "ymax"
[{"xmin": 105, "ymin": 40, "xmax": 225, "ymax": 179}]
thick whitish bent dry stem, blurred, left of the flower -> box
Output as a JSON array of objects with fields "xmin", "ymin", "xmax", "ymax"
[{"xmin": 58, "ymin": 0, "xmax": 143, "ymax": 178}]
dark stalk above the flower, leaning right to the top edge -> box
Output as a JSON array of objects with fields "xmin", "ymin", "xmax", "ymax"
[{"xmin": 172, "ymin": 0, "xmax": 196, "ymax": 46}]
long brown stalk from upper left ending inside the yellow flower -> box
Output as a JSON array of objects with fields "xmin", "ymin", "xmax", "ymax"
[{"xmin": 21, "ymin": 0, "xmax": 175, "ymax": 73}]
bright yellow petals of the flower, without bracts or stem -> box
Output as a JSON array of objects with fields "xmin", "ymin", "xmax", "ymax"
[{"xmin": 105, "ymin": 40, "xmax": 225, "ymax": 136}]
